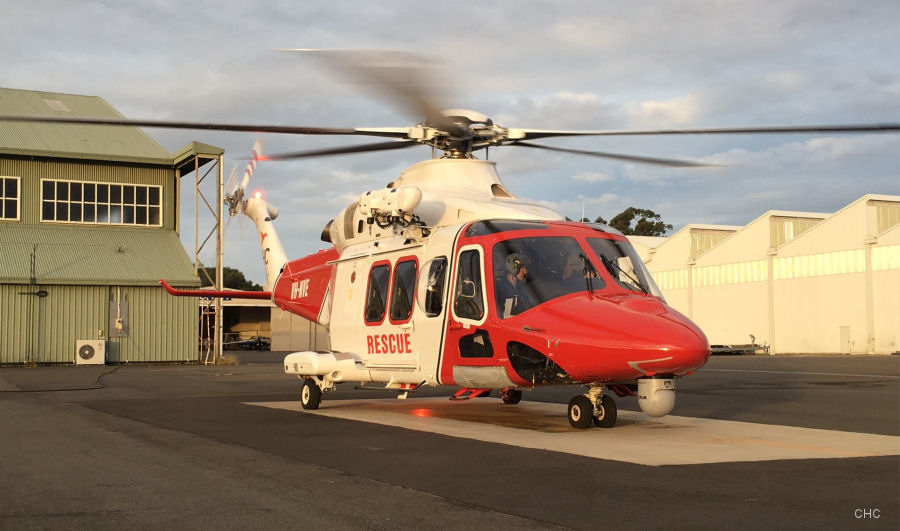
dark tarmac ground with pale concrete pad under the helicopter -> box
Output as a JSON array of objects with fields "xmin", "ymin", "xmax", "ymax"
[{"xmin": 0, "ymin": 351, "xmax": 900, "ymax": 529}]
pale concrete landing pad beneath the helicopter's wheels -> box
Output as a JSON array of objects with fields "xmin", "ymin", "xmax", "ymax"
[{"xmin": 245, "ymin": 398, "xmax": 900, "ymax": 466}]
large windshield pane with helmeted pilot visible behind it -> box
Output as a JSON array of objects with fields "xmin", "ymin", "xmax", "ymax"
[{"xmin": 492, "ymin": 236, "xmax": 606, "ymax": 319}]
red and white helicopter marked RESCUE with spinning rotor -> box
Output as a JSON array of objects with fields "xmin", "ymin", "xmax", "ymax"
[{"xmin": 0, "ymin": 54, "xmax": 900, "ymax": 429}]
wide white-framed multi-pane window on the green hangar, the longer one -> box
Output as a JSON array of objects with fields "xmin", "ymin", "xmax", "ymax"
[{"xmin": 41, "ymin": 179, "xmax": 162, "ymax": 227}]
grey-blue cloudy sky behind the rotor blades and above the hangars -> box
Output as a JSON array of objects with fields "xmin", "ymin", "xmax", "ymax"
[{"xmin": 0, "ymin": 0, "xmax": 900, "ymax": 283}]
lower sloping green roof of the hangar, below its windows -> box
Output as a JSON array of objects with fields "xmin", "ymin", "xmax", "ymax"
[{"xmin": 0, "ymin": 224, "xmax": 199, "ymax": 286}]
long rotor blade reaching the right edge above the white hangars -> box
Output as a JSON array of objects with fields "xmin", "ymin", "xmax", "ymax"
[{"xmin": 510, "ymin": 123, "xmax": 900, "ymax": 140}]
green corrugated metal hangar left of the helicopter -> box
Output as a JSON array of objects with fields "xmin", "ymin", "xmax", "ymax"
[{"xmin": 0, "ymin": 89, "xmax": 222, "ymax": 365}]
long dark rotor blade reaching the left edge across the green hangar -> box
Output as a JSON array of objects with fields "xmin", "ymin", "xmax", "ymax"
[{"xmin": 0, "ymin": 115, "xmax": 360, "ymax": 136}]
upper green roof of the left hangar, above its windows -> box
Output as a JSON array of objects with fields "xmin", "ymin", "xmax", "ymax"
[{"xmin": 0, "ymin": 88, "xmax": 173, "ymax": 166}]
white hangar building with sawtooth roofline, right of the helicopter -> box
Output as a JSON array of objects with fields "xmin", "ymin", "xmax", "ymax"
[{"xmin": 635, "ymin": 194, "xmax": 900, "ymax": 354}]
